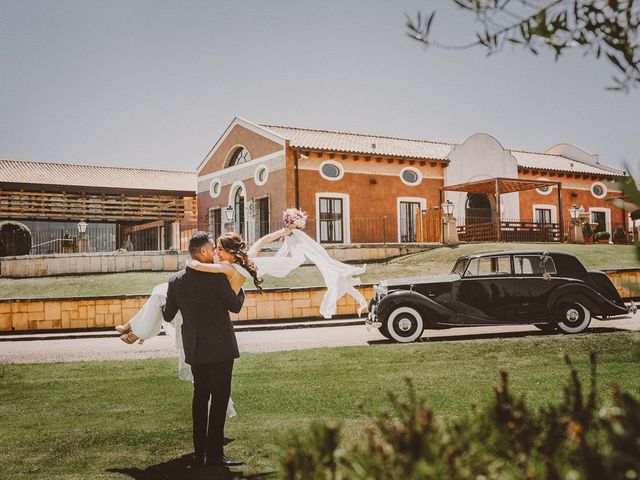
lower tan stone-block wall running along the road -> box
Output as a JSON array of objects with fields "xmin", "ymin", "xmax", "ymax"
[{"xmin": 0, "ymin": 286, "xmax": 373, "ymax": 332}]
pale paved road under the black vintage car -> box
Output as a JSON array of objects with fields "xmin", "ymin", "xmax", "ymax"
[{"xmin": 0, "ymin": 313, "xmax": 640, "ymax": 363}]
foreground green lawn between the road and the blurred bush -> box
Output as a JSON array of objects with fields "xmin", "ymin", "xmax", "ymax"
[{"xmin": 0, "ymin": 332, "xmax": 640, "ymax": 479}]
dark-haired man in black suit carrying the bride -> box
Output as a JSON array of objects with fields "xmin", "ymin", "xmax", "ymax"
[{"xmin": 163, "ymin": 232, "xmax": 244, "ymax": 466}]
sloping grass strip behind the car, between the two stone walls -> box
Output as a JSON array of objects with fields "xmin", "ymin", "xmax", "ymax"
[{"xmin": 0, "ymin": 243, "xmax": 638, "ymax": 298}]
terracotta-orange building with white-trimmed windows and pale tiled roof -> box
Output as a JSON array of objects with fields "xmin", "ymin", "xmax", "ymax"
[{"xmin": 197, "ymin": 118, "xmax": 629, "ymax": 244}]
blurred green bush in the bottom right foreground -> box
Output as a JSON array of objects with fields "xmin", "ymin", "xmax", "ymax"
[{"xmin": 282, "ymin": 354, "xmax": 640, "ymax": 480}]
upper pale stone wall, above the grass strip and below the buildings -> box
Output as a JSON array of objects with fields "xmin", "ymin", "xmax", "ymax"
[{"xmin": 0, "ymin": 245, "xmax": 430, "ymax": 278}]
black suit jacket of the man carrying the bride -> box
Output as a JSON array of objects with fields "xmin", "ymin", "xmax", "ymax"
[{"xmin": 163, "ymin": 268, "xmax": 244, "ymax": 365}]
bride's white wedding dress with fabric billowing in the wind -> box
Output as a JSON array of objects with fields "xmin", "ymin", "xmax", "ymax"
[{"xmin": 129, "ymin": 230, "xmax": 367, "ymax": 416}]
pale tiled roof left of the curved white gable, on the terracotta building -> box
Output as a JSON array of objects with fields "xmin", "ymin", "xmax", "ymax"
[{"xmin": 260, "ymin": 124, "xmax": 451, "ymax": 160}]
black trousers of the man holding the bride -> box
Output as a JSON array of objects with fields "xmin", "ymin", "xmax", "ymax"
[{"xmin": 191, "ymin": 360, "xmax": 233, "ymax": 459}]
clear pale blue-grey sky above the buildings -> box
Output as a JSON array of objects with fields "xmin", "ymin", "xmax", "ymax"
[{"xmin": 0, "ymin": 0, "xmax": 640, "ymax": 176}]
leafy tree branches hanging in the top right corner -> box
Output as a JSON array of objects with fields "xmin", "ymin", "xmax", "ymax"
[{"xmin": 406, "ymin": 0, "xmax": 640, "ymax": 92}]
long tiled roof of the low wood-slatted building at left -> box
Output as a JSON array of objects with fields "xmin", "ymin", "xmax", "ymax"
[{"xmin": 0, "ymin": 160, "xmax": 197, "ymax": 196}]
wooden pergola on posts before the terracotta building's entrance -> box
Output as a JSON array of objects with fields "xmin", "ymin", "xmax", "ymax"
[{"xmin": 439, "ymin": 177, "xmax": 564, "ymax": 241}]
